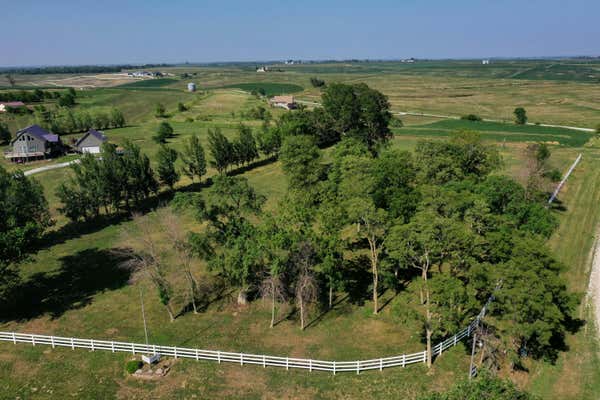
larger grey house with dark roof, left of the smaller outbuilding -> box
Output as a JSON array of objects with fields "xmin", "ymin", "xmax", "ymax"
[{"xmin": 4, "ymin": 125, "xmax": 63, "ymax": 162}]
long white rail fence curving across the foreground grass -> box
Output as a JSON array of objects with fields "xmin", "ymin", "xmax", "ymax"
[{"xmin": 0, "ymin": 290, "xmax": 493, "ymax": 374}]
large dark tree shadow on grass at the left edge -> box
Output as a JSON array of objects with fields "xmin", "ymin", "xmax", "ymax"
[{"xmin": 0, "ymin": 248, "xmax": 132, "ymax": 321}]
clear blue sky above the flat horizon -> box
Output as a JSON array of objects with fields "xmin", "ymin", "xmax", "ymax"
[{"xmin": 0, "ymin": 0, "xmax": 600, "ymax": 66}]
